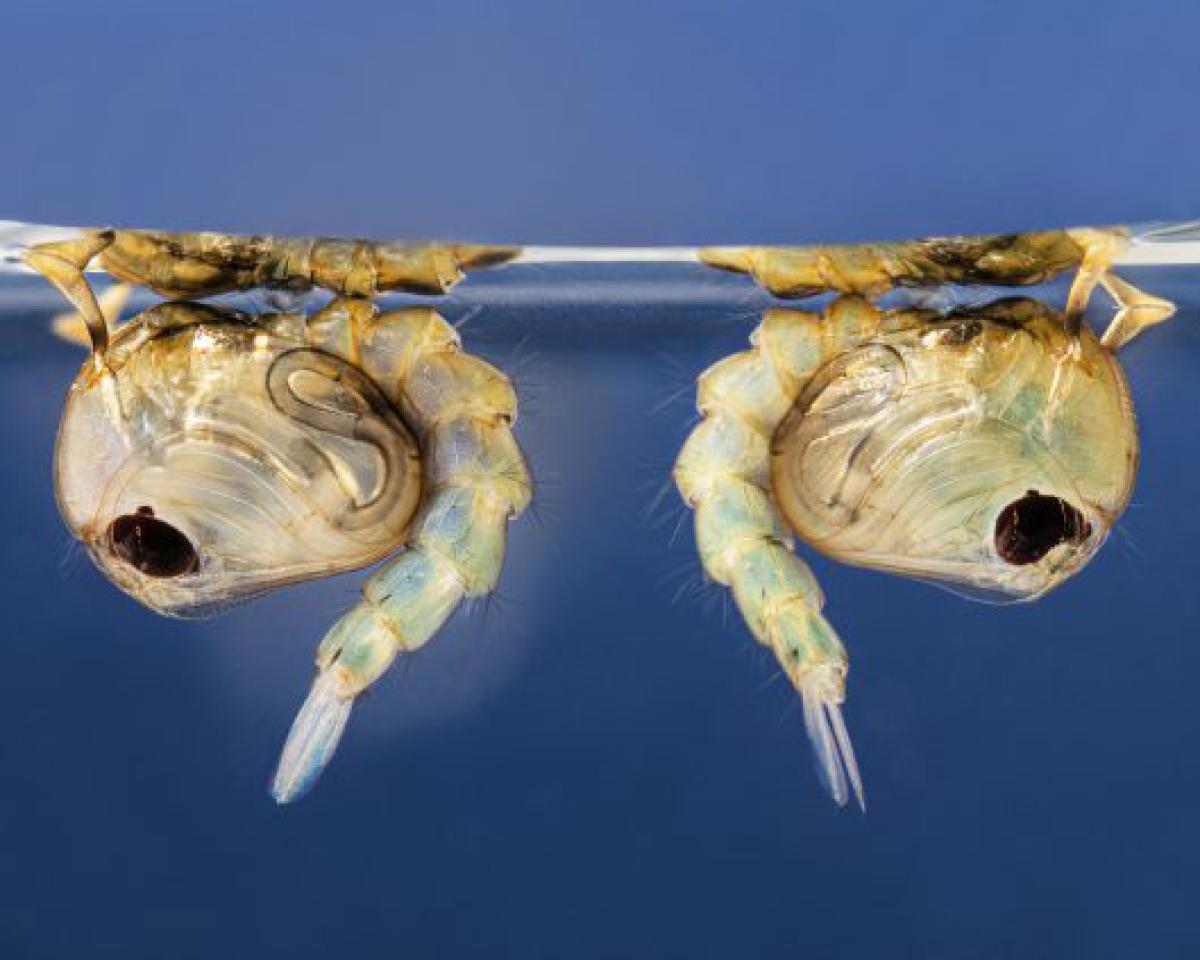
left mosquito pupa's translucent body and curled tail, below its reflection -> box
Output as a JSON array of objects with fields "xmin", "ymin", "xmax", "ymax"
[{"xmin": 55, "ymin": 300, "xmax": 530, "ymax": 802}]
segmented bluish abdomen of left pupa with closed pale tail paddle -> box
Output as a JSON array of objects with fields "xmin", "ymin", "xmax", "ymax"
[{"xmin": 272, "ymin": 310, "xmax": 530, "ymax": 803}]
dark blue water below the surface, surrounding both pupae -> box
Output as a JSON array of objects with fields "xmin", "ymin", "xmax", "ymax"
[{"xmin": 0, "ymin": 264, "xmax": 1200, "ymax": 960}]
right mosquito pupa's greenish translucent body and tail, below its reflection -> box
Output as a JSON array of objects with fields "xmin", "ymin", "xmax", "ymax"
[{"xmin": 674, "ymin": 296, "xmax": 1138, "ymax": 803}]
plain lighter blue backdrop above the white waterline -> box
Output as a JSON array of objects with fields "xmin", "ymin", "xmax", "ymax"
[{"xmin": 0, "ymin": 0, "xmax": 1200, "ymax": 244}]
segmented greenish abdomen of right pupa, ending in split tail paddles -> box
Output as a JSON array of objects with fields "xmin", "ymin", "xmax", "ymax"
[{"xmin": 674, "ymin": 326, "xmax": 878, "ymax": 809}]
